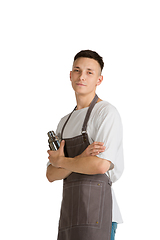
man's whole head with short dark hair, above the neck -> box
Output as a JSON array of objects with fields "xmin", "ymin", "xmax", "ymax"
[{"xmin": 70, "ymin": 50, "xmax": 104, "ymax": 95}]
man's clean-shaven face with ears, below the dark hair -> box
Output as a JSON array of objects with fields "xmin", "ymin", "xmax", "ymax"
[{"xmin": 70, "ymin": 57, "xmax": 103, "ymax": 94}]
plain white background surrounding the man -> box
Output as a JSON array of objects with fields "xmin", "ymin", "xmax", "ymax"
[{"xmin": 0, "ymin": 0, "xmax": 160, "ymax": 240}]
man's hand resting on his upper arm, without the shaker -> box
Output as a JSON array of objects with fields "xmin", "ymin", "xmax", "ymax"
[{"xmin": 78, "ymin": 142, "xmax": 106, "ymax": 157}]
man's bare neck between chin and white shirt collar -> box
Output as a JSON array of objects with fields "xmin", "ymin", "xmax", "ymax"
[{"xmin": 76, "ymin": 93, "xmax": 95, "ymax": 110}]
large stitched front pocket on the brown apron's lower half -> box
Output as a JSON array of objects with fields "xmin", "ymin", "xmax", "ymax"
[{"xmin": 59, "ymin": 180, "xmax": 105, "ymax": 230}]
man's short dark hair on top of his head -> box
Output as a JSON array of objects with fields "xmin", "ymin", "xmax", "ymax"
[{"xmin": 74, "ymin": 50, "xmax": 104, "ymax": 71}]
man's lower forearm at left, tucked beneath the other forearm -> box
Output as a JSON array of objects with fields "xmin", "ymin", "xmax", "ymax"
[{"xmin": 46, "ymin": 165, "xmax": 72, "ymax": 182}]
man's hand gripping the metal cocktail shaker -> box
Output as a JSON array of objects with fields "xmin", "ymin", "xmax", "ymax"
[{"xmin": 47, "ymin": 140, "xmax": 65, "ymax": 168}]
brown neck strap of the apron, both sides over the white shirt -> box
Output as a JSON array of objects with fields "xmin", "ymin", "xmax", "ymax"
[{"xmin": 61, "ymin": 94, "xmax": 98, "ymax": 139}]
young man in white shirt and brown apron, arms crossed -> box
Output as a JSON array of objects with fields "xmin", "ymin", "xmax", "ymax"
[{"xmin": 46, "ymin": 50, "xmax": 123, "ymax": 240}]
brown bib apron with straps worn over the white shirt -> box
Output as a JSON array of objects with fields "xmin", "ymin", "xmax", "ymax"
[{"xmin": 57, "ymin": 95, "xmax": 112, "ymax": 240}]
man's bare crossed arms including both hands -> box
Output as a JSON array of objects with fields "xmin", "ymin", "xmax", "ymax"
[{"xmin": 46, "ymin": 140, "xmax": 111, "ymax": 182}]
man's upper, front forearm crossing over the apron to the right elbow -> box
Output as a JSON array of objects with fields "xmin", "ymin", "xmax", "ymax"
[{"xmin": 59, "ymin": 156, "xmax": 110, "ymax": 175}]
